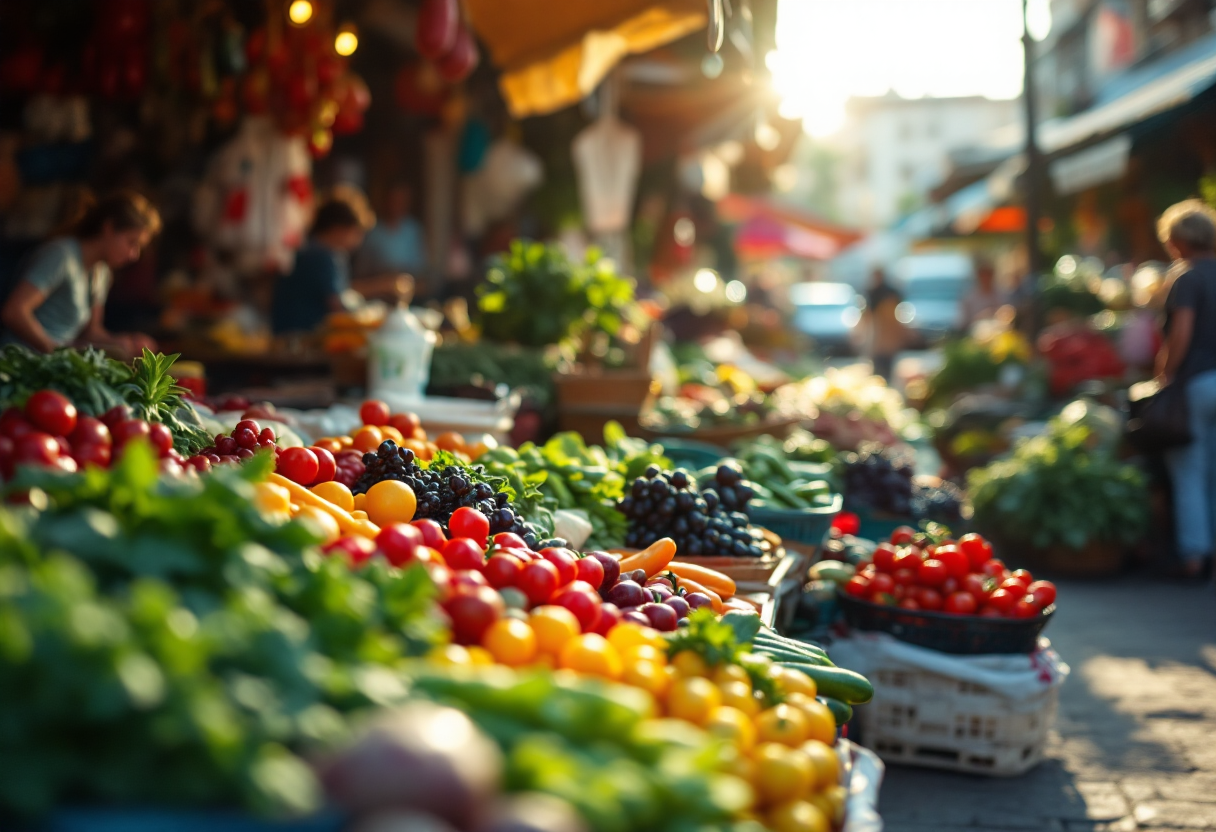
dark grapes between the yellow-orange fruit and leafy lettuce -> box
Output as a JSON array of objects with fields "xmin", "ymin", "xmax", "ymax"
[{"xmin": 350, "ymin": 439, "xmax": 539, "ymax": 546}]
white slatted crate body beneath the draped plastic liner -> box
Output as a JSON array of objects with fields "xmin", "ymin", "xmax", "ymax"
[{"xmin": 854, "ymin": 651, "xmax": 1059, "ymax": 777}]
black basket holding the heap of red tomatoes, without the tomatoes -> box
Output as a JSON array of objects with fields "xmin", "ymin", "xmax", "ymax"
[{"xmin": 837, "ymin": 591, "xmax": 1055, "ymax": 656}]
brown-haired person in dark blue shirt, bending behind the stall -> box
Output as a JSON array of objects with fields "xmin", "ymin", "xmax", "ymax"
[{"xmin": 270, "ymin": 186, "xmax": 376, "ymax": 335}]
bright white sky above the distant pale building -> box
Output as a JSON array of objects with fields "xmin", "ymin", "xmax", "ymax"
[{"xmin": 769, "ymin": 0, "xmax": 1051, "ymax": 136}]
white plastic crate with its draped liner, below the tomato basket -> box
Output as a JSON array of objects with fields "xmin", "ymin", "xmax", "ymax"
[{"xmin": 832, "ymin": 634, "xmax": 1068, "ymax": 776}]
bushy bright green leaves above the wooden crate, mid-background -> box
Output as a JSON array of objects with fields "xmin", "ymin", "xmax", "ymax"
[{"xmin": 478, "ymin": 240, "xmax": 637, "ymax": 347}]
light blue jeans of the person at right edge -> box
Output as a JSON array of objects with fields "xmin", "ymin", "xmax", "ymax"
[{"xmin": 1165, "ymin": 370, "xmax": 1216, "ymax": 561}]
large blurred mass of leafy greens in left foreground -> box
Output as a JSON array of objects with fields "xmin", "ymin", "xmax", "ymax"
[{"xmin": 0, "ymin": 452, "xmax": 441, "ymax": 815}]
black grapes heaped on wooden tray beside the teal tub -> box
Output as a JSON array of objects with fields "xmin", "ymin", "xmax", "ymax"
[{"xmin": 618, "ymin": 465, "xmax": 764, "ymax": 557}]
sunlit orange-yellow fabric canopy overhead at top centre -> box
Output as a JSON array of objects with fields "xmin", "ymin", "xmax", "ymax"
[{"xmin": 465, "ymin": 0, "xmax": 706, "ymax": 118}]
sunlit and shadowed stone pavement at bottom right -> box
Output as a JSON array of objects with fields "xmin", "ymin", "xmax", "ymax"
[{"xmin": 879, "ymin": 578, "xmax": 1216, "ymax": 832}]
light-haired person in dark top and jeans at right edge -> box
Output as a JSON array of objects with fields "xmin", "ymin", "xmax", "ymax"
[{"xmin": 1156, "ymin": 199, "xmax": 1216, "ymax": 577}]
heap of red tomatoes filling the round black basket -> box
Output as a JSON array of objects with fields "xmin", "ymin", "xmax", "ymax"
[{"xmin": 836, "ymin": 527, "xmax": 1055, "ymax": 618}]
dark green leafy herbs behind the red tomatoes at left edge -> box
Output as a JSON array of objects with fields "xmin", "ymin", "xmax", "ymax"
[{"xmin": 0, "ymin": 344, "xmax": 212, "ymax": 456}]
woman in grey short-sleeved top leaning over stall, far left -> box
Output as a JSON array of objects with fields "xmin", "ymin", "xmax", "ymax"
[{"xmin": 0, "ymin": 191, "xmax": 161, "ymax": 359}]
